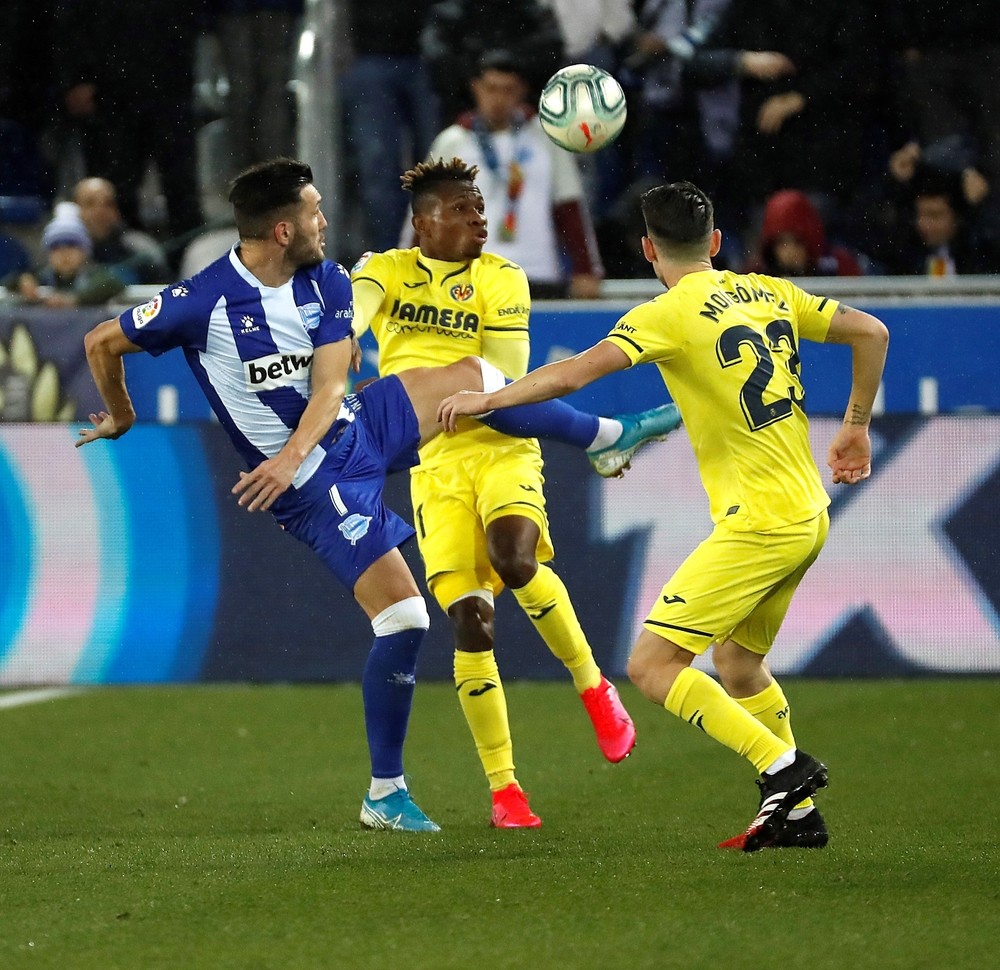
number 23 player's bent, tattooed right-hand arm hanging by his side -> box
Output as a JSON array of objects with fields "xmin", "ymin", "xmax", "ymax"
[{"xmin": 826, "ymin": 304, "xmax": 889, "ymax": 485}]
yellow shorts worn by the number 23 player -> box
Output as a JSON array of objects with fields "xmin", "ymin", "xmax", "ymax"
[{"xmin": 643, "ymin": 509, "xmax": 830, "ymax": 655}]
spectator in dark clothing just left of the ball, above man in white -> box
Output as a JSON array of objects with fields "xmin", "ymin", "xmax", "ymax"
[{"xmin": 420, "ymin": 0, "xmax": 565, "ymax": 125}]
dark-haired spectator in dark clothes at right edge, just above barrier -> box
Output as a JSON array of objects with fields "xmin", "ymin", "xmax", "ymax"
[{"xmin": 885, "ymin": 168, "xmax": 1000, "ymax": 276}]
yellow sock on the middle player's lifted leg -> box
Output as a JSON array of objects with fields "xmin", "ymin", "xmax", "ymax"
[{"xmin": 511, "ymin": 565, "xmax": 601, "ymax": 694}]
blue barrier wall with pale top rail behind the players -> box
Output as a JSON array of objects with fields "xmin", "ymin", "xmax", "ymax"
[{"xmin": 0, "ymin": 277, "xmax": 1000, "ymax": 423}]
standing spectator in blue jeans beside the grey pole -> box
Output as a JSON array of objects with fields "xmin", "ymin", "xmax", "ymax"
[{"xmin": 341, "ymin": 0, "xmax": 441, "ymax": 251}]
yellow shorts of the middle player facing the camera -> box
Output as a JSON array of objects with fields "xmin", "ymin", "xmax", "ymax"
[{"xmin": 410, "ymin": 440, "xmax": 555, "ymax": 610}]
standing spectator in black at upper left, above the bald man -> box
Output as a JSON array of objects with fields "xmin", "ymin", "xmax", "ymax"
[{"xmin": 52, "ymin": 0, "xmax": 208, "ymax": 237}]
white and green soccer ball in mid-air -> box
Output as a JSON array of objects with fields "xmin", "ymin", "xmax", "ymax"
[{"xmin": 538, "ymin": 64, "xmax": 627, "ymax": 152}]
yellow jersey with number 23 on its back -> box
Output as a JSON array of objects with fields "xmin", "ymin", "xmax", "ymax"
[{"xmin": 605, "ymin": 270, "xmax": 838, "ymax": 532}]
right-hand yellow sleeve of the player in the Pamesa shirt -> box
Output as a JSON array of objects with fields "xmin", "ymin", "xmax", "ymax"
[{"xmin": 480, "ymin": 262, "xmax": 531, "ymax": 380}]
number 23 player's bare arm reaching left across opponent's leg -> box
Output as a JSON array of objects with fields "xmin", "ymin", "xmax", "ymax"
[{"xmin": 438, "ymin": 340, "xmax": 630, "ymax": 431}]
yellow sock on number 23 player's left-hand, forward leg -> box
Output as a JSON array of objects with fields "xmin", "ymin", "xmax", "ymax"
[{"xmin": 663, "ymin": 667, "xmax": 791, "ymax": 772}]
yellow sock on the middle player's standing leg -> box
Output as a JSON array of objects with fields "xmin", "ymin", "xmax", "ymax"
[{"xmin": 455, "ymin": 650, "xmax": 515, "ymax": 791}]
